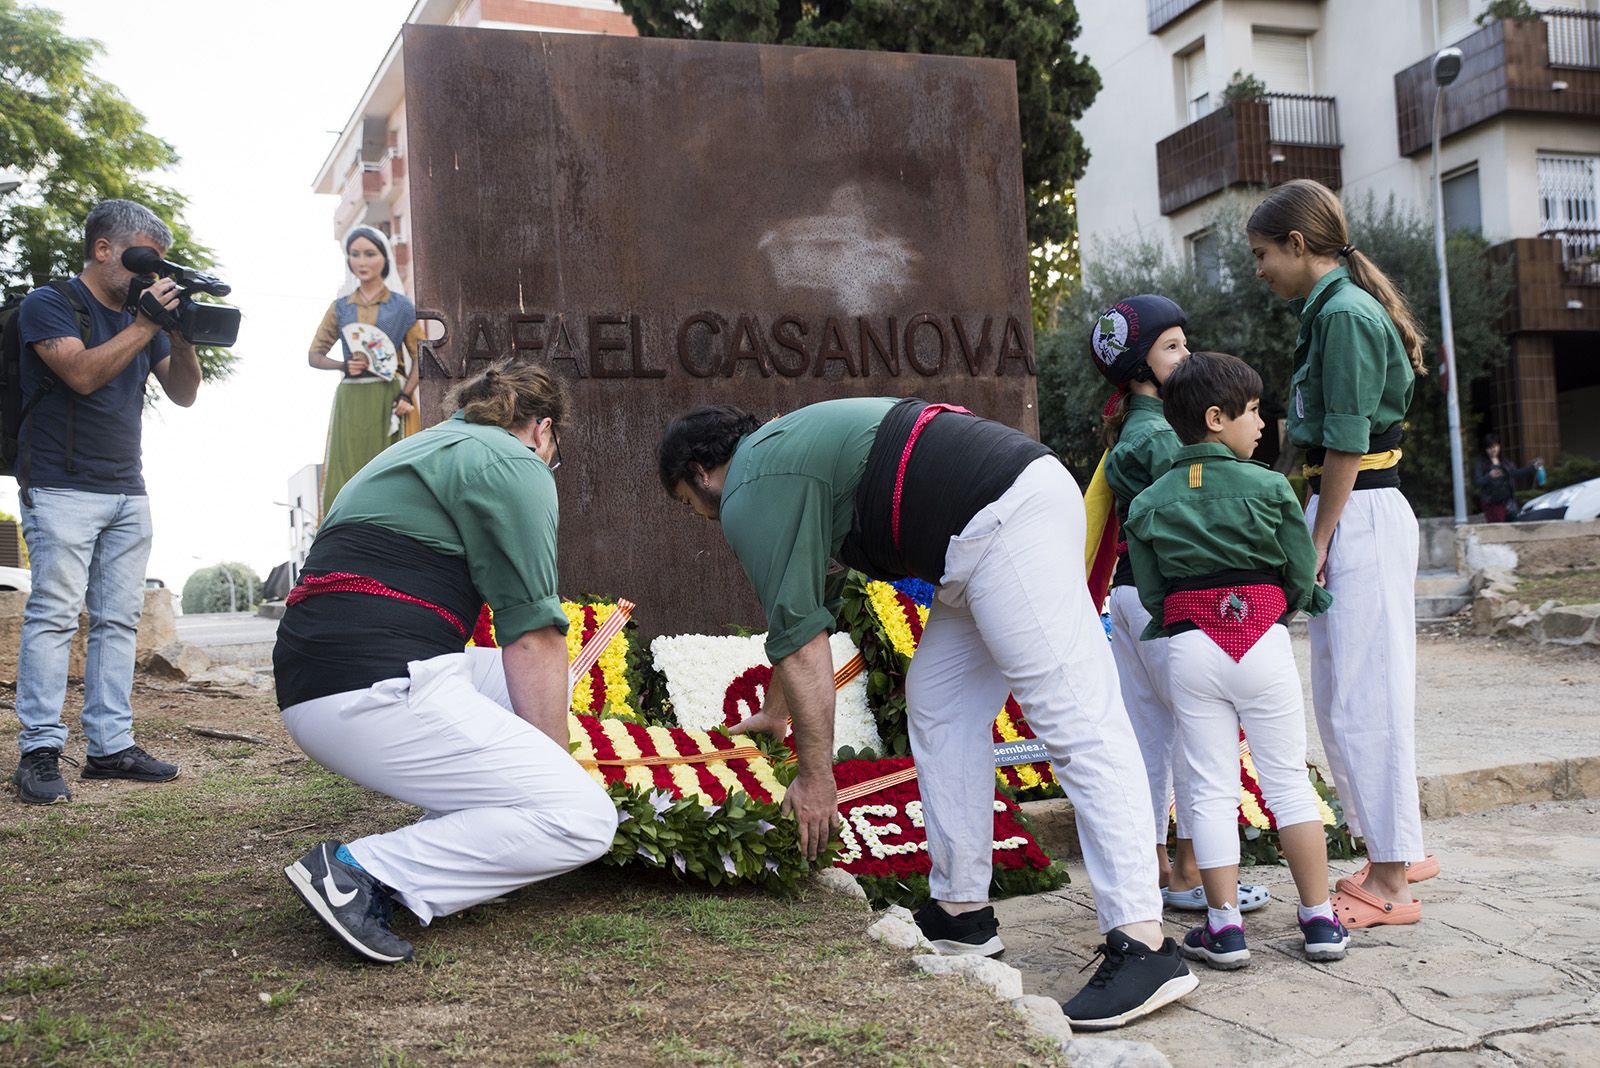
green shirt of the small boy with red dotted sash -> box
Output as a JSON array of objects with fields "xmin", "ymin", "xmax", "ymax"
[{"xmin": 1126, "ymin": 441, "xmax": 1333, "ymax": 641}]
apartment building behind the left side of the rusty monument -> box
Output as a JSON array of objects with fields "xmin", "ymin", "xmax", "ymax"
[{"xmin": 312, "ymin": 0, "xmax": 638, "ymax": 291}]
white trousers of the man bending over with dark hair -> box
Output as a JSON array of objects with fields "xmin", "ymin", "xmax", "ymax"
[{"xmin": 906, "ymin": 456, "xmax": 1162, "ymax": 932}]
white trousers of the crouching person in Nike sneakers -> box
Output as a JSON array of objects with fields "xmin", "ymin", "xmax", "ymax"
[{"xmin": 283, "ymin": 648, "xmax": 616, "ymax": 924}]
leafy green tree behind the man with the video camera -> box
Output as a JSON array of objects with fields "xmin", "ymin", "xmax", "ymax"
[{"xmin": 0, "ymin": 0, "xmax": 234, "ymax": 379}]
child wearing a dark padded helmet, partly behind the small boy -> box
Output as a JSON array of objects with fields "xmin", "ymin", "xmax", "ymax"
[{"xmin": 1090, "ymin": 294, "xmax": 1269, "ymax": 911}]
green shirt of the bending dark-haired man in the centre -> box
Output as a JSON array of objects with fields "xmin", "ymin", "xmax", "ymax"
[{"xmin": 726, "ymin": 397, "xmax": 896, "ymax": 664}]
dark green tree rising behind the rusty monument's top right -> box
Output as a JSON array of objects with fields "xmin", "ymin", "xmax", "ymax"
[{"xmin": 621, "ymin": 0, "xmax": 1099, "ymax": 326}]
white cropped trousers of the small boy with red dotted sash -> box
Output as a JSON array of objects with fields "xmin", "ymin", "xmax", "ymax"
[{"xmin": 1168, "ymin": 624, "xmax": 1322, "ymax": 868}]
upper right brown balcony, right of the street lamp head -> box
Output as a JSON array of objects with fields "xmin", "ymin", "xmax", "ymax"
[{"xmin": 1395, "ymin": 11, "xmax": 1600, "ymax": 155}]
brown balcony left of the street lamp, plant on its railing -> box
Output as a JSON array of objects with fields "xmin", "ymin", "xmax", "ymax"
[{"xmin": 1155, "ymin": 93, "xmax": 1341, "ymax": 216}]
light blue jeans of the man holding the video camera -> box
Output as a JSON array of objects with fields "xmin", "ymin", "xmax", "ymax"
[{"xmin": 16, "ymin": 488, "xmax": 152, "ymax": 756}]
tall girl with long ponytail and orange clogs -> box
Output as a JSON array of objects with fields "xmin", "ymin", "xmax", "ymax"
[{"xmin": 1245, "ymin": 179, "xmax": 1438, "ymax": 927}]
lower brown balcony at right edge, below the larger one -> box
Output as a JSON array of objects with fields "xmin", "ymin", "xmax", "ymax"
[{"xmin": 1490, "ymin": 230, "xmax": 1600, "ymax": 334}]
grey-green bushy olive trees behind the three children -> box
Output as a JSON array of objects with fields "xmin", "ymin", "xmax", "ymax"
[{"xmin": 1038, "ymin": 197, "xmax": 1510, "ymax": 515}]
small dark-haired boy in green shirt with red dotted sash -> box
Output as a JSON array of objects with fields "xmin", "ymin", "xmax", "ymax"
[{"xmin": 1126, "ymin": 352, "xmax": 1349, "ymax": 969}]
